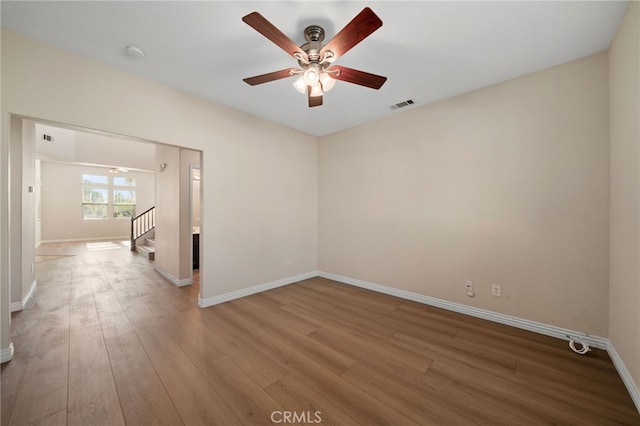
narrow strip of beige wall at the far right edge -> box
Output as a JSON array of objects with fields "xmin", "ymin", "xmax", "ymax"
[{"xmin": 609, "ymin": 2, "xmax": 640, "ymax": 402}]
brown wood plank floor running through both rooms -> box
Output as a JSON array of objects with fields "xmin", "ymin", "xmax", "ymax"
[{"xmin": 1, "ymin": 241, "xmax": 640, "ymax": 425}]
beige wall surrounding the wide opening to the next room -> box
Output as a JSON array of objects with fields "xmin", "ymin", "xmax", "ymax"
[{"xmin": 2, "ymin": 29, "xmax": 318, "ymax": 303}]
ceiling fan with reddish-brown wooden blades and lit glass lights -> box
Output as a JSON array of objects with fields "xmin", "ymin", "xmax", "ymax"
[{"xmin": 242, "ymin": 7, "xmax": 387, "ymax": 107}]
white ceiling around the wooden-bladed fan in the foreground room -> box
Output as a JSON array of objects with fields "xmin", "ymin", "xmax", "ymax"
[{"xmin": 1, "ymin": 1, "xmax": 627, "ymax": 136}]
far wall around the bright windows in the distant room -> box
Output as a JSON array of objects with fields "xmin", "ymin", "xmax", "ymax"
[{"xmin": 41, "ymin": 161, "xmax": 155, "ymax": 242}]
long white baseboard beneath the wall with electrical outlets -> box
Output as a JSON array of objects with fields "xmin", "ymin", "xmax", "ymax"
[{"xmin": 318, "ymin": 272, "xmax": 609, "ymax": 350}]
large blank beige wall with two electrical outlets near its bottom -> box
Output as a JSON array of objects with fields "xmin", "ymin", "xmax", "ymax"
[{"xmin": 318, "ymin": 54, "xmax": 609, "ymax": 336}]
